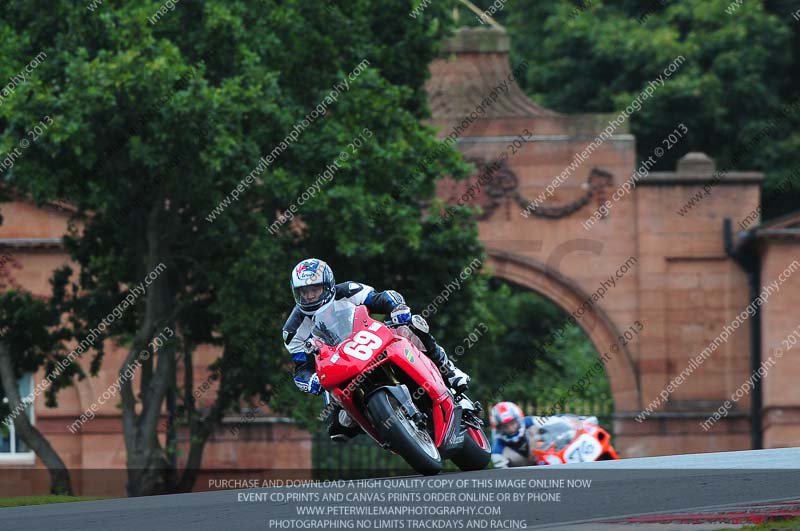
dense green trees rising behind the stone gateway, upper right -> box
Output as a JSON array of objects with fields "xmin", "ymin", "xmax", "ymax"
[{"xmin": 476, "ymin": 0, "xmax": 800, "ymax": 218}]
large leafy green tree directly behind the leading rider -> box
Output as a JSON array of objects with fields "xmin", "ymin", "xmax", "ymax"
[{"xmin": 0, "ymin": 0, "xmax": 496, "ymax": 495}]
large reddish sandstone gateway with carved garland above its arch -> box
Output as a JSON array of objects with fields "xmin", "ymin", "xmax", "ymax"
[{"xmin": 427, "ymin": 28, "xmax": 763, "ymax": 457}]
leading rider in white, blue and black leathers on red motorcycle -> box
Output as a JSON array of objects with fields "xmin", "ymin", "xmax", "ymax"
[{"xmin": 283, "ymin": 258, "xmax": 470, "ymax": 442}]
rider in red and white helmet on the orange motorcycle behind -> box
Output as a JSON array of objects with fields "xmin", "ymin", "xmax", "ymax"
[{"xmin": 490, "ymin": 402, "xmax": 597, "ymax": 468}]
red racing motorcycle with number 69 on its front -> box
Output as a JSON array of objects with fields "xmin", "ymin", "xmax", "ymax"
[{"xmin": 309, "ymin": 300, "xmax": 491, "ymax": 475}]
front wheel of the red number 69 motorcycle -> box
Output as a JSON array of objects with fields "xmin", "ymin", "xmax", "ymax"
[{"xmin": 367, "ymin": 390, "xmax": 442, "ymax": 476}]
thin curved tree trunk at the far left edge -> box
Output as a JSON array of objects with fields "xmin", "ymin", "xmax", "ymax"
[{"xmin": 0, "ymin": 343, "xmax": 72, "ymax": 496}]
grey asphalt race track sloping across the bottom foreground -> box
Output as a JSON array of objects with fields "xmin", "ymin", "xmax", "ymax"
[{"xmin": 0, "ymin": 448, "xmax": 800, "ymax": 531}]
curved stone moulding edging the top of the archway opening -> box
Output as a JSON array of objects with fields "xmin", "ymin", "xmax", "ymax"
[{"xmin": 487, "ymin": 249, "xmax": 641, "ymax": 411}]
